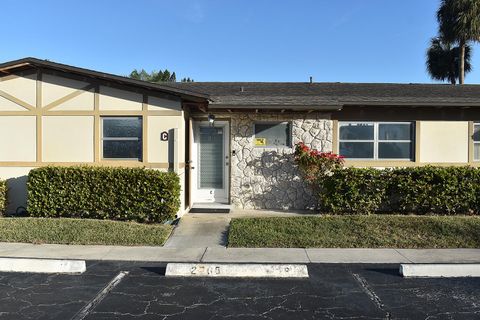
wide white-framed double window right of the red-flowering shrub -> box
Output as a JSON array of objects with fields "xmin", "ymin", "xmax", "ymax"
[{"xmin": 339, "ymin": 122, "xmax": 414, "ymax": 160}]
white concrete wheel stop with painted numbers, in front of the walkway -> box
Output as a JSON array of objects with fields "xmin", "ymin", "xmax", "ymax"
[{"xmin": 165, "ymin": 263, "xmax": 308, "ymax": 278}]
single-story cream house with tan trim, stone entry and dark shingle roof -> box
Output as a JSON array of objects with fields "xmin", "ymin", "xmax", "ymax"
[{"xmin": 0, "ymin": 58, "xmax": 480, "ymax": 216}]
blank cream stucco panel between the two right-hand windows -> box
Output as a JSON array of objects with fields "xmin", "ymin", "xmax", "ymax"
[{"xmin": 419, "ymin": 121, "xmax": 469, "ymax": 163}]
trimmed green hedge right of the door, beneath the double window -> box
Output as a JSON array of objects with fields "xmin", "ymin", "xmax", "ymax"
[{"xmin": 318, "ymin": 166, "xmax": 480, "ymax": 215}]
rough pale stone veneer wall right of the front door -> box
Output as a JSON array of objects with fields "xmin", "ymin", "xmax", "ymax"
[{"xmin": 216, "ymin": 113, "xmax": 333, "ymax": 210}]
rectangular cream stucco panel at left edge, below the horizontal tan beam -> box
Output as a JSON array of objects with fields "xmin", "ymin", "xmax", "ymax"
[{"xmin": 0, "ymin": 113, "xmax": 37, "ymax": 162}]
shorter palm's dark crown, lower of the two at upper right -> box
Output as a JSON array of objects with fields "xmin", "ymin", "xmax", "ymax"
[{"xmin": 427, "ymin": 38, "xmax": 472, "ymax": 84}]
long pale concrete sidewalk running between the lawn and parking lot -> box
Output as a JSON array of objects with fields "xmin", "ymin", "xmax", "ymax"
[{"xmin": 0, "ymin": 242, "xmax": 480, "ymax": 263}]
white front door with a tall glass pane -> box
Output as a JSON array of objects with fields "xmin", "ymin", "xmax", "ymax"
[{"xmin": 191, "ymin": 121, "xmax": 230, "ymax": 203}]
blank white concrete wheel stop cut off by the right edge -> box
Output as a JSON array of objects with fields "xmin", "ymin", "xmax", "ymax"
[{"xmin": 400, "ymin": 263, "xmax": 480, "ymax": 278}]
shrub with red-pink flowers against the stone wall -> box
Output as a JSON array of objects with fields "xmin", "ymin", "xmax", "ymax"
[{"xmin": 295, "ymin": 142, "xmax": 344, "ymax": 183}]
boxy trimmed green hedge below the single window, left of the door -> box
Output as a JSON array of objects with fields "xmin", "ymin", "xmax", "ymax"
[{"xmin": 27, "ymin": 166, "xmax": 180, "ymax": 222}]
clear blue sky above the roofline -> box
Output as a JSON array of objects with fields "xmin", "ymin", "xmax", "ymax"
[{"xmin": 0, "ymin": 0, "xmax": 480, "ymax": 83}]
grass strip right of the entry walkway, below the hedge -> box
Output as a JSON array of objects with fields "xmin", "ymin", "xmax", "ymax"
[{"xmin": 228, "ymin": 215, "xmax": 480, "ymax": 248}]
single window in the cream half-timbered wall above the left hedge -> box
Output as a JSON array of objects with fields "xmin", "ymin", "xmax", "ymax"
[{"xmin": 102, "ymin": 117, "xmax": 142, "ymax": 161}]
